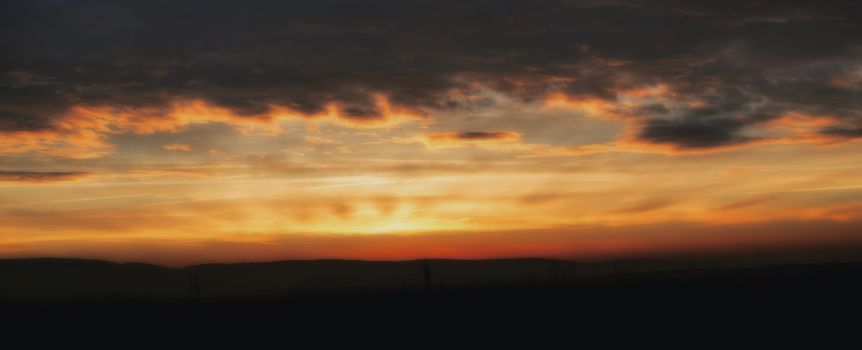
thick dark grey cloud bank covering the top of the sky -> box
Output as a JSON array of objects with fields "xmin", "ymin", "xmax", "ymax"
[{"xmin": 0, "ymin": 0, "xmax": 862, "ymax": 148}]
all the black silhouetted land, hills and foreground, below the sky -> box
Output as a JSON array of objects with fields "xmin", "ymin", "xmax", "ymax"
[{"xmin": 0, "ymin": 259, "xmax": 862, "ymax": 349}]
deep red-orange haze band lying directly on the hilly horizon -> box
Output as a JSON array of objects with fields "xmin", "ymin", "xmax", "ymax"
[{"xmin": 5, "ymin": 220, "xmax": 862, "ymax": 266}]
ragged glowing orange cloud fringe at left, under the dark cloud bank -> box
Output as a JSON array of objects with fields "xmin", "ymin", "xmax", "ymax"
[{"xmin": 0, "ymin": 94, "xmax": 426, "ymax": 159}]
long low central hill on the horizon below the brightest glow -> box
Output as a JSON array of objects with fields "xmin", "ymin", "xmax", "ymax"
[{"xmin": 184, "ymin": 259, "xmax": 604, "ymax": 297}]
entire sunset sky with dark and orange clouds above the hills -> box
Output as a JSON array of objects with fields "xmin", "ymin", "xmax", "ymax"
[{"xmin": 0, "ymin": 0, "xmax": 862, "ymax": 265}]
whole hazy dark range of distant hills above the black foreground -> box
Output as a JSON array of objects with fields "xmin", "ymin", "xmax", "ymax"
[{"xmin": 0, "ymin": 258, "xmax": 858, "ymax": 300}]
